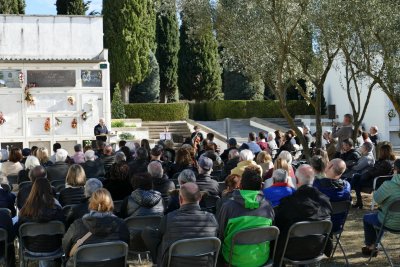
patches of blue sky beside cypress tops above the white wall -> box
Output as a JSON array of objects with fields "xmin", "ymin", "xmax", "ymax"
[{"xmin": 25, "ymin": 0, "xmax": 102, "ymax": 15}]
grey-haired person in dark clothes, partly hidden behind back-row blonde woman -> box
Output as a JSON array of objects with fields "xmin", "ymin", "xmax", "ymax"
[{"xmin": 66, "ymin": 178, "xmax": 103, "ymax": 230}]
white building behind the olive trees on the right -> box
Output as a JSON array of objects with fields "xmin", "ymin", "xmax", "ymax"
[{"xmin": 324, "ymin": 56, "xmax": 400, "ymax": 147}]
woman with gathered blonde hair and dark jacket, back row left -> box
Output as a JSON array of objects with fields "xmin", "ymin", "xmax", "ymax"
[{"xmin": 62, "ymin": 188, "xmax": 129, "ymax": 266}]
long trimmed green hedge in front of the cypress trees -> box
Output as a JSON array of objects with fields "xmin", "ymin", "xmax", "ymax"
[{"xmin": 125, "ymin": 100, "xmax": 314, "ymax": 121}]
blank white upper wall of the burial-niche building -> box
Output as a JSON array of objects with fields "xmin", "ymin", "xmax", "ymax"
[{"xmin": 0, "ymin": 15, "xmax": 103, "ymax": 59}]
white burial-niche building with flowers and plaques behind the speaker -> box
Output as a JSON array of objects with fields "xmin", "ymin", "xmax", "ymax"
[{"xmin": 0, "ymin": 15, "xmax": 111, "ymax": 153}]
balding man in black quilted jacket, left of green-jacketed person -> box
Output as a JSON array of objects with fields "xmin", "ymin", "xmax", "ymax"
[{"xmin": 142, "ymin": 183, "xmax": 218, "ymax": 266}]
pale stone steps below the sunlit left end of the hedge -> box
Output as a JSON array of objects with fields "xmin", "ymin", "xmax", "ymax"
[{"xmin": 142, "ymin": 121, "xmax": 191, "ymax": 145}]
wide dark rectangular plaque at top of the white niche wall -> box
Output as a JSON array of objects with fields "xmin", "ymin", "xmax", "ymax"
[{"xmin": 27, "ymin": 70, "xmax": 76, "ymax": 87}]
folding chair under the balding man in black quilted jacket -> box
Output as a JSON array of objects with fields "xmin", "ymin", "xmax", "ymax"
[{"xmin": 167, "ymin": 237, "xmax": 221, "ymax": 267}]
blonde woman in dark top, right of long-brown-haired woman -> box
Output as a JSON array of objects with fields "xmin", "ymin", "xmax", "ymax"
[{"xmin": 59, "ymin": 164, "xmax": 86, "ymax": 206}]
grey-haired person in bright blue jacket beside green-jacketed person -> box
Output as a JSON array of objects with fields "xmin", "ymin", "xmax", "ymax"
[{"xmin": 263, "ymin": 169, "xmax": 296, "ymax": 208}]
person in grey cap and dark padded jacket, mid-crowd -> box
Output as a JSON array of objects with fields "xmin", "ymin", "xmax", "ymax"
[{"xmin": 196, "ymin": 156, "xmax": 220, "ymax": 196}]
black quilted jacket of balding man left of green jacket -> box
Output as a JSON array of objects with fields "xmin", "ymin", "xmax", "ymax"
[{"xmin": 157, "ymin": 204, "xmax": 218, "ymax": 267}]
